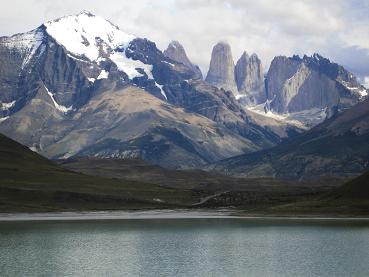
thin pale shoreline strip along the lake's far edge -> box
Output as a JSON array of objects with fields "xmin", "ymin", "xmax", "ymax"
[{"xmin": 0, "ymin": 210, "xmax": 369, "ymax": 223}]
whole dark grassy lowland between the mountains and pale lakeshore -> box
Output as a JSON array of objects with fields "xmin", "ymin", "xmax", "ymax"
[{"xmin": 0, "ymin": 135, "xmax": 369, "ymax": 216}]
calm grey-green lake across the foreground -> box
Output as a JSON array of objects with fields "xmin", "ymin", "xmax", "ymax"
[{"xmin": 0, "ymin": 213, "xmax": 369, "ymax": 277}]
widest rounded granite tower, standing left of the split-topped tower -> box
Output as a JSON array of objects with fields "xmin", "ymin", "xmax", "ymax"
[{"xmin": 205, "ymin": 42, "xmax": 237, "ymax": 94}]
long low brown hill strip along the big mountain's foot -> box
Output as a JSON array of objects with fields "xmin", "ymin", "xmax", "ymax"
[{"xmin": 57, "ymin": 157, "xmax": 332, "ymax": 193}]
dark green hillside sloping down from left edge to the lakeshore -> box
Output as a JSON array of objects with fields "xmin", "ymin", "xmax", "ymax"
[{"xmin": 0, "ymin": 135, "xmax": 201, "ymax": 212}]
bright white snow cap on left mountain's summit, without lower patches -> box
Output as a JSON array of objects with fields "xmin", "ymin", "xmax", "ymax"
[{"xmin": 44, "ymin": 11, "xmax": 135, "ymax": 61}]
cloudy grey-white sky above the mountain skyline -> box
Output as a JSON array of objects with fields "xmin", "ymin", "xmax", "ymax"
[{"xmin": 0, "ymin": 0, "xmax": 369, "ymax": 87}]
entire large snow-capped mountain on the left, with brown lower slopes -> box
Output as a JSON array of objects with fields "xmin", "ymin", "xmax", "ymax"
[{"xmin": 0, "ymin": 12, "xmax": 281, "ymax": 167}]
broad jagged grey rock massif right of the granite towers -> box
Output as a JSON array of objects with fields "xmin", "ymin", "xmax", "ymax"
[{"xmin": 266, "ymin": 54, "xmax": 367, "ymax": 114}]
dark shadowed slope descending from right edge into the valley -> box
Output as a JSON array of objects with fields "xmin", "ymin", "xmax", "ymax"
[{"xmin": 210, "ymin": 99, "xmax": 369, "ymax": 180}]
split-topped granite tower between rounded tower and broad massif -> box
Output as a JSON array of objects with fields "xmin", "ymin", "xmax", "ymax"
[{"xmin": 235, "ymin": 52, "xmax": 266, "ymax": 105}]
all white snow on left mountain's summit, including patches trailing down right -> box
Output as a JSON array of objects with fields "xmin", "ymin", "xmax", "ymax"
[{"xmin": 45, "ymin": 11, "xmax": 166, "ymax": 98}]
